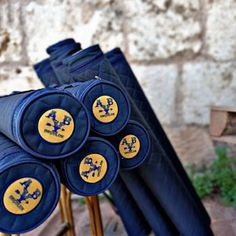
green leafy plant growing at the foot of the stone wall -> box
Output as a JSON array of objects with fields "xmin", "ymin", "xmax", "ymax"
[{"xmin": 188, "ymin": 148, "xmax": 236, "ymax": 207}]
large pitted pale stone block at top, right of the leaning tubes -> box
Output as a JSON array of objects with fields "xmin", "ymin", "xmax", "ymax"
[{"xmin": 126, "ymin": 0, "xmax": 202, "ymax": 60}]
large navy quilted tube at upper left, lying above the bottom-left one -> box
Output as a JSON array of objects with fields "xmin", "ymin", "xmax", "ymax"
[{"xmin": 0, "ymin": 88, "xmax": 90, "ymax": 159}]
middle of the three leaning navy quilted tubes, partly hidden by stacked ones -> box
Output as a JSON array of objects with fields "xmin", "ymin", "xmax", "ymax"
[{"xmin": 56, "ymin": 45, "xmax": 212, "ymax": 236}]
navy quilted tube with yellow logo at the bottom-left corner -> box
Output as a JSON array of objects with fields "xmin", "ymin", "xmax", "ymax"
[{"xmin": 0, "ymin": 135, "xmax": 60, "ymax": 234}]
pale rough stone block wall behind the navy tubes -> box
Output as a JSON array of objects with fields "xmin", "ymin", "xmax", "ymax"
[{"xmin": 0, "ymin": 0, "xmax": 236, "ymax": 163}]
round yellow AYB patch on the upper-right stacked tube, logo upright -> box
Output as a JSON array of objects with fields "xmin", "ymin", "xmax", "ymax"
[{"xmin": 92, "ymin": 95, "xmax": 119, "ymax": 123}]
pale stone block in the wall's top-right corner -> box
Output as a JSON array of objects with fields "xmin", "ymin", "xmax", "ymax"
[{"xmin": 206, "ymin": 1, "xmax": 236, "ymax": 60}]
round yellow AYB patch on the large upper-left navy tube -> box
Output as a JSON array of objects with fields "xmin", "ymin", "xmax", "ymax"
[{"xmin": 38, "ymin": 109, "xmax": 74, "ymax": 143}]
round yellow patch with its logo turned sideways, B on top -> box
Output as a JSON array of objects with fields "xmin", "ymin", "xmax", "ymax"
[{"xmin": 79, "ymin": 153, "xmax": 107, "ymax": 183}]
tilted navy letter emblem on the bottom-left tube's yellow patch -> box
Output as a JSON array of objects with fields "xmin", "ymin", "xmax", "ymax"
[{"xmin": 15, "ymin": 179, "xmax": 41, "ymax": 204}]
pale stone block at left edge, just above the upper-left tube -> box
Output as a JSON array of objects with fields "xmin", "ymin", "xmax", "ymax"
[{"xmin": 0, "ymin": 66, "xmax": 43, "ymax": 95}]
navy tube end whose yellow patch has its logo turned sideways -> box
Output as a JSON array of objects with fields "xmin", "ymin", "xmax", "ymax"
[{"xmin": 60, "ymin": 137, "xmax": 120, "ymax": 196}]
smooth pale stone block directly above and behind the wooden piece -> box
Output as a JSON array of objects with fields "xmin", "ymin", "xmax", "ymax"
[{"xmin": 181, "ymin": 62, "xmax": 236, "ymax": 125}]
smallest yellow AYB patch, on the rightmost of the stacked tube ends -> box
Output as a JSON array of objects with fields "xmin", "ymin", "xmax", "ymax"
[{"xmin": 119, "ymin": 134, "xmax": 140, "ymax": 159}]
